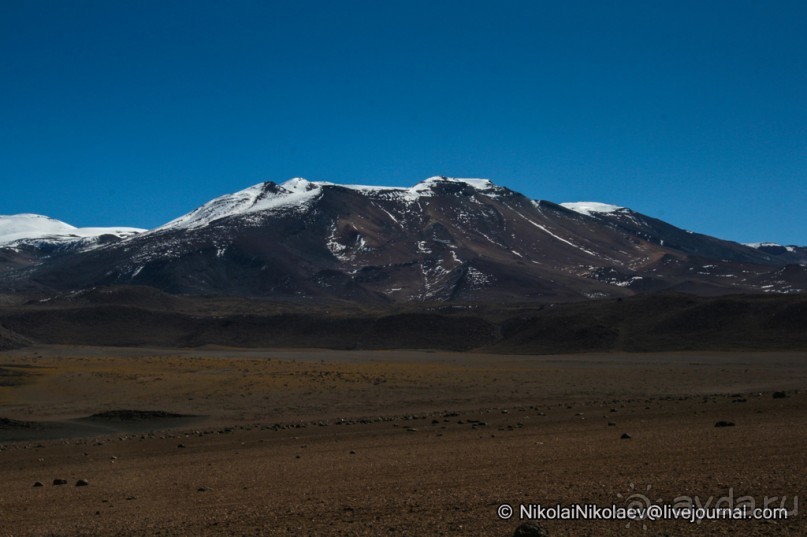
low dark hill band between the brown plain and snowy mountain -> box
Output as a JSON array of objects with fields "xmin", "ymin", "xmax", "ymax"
[{"xmin": 0, "ymin": 287, "xmax": 807, "ymax": 354}]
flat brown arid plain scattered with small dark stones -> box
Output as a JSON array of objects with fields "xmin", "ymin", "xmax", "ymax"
[{"xmin": 0, "ymin": 346, "xmax": 807, "ymax": 537}]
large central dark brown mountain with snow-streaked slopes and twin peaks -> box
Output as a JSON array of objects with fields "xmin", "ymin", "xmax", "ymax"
[{"xmin": 3, "ymin": 177, "xmax": 807, "ymax": 302}]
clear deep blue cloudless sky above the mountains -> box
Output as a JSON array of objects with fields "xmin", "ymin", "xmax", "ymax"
[{"xmin": 0, "ymin": 0, "xmax": 807, "ymax": 245}]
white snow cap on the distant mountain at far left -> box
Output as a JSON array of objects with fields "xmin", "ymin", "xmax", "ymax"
[{"xmin": 0, "ymin": 214, "xmax": 145, "ymax": 244}]
